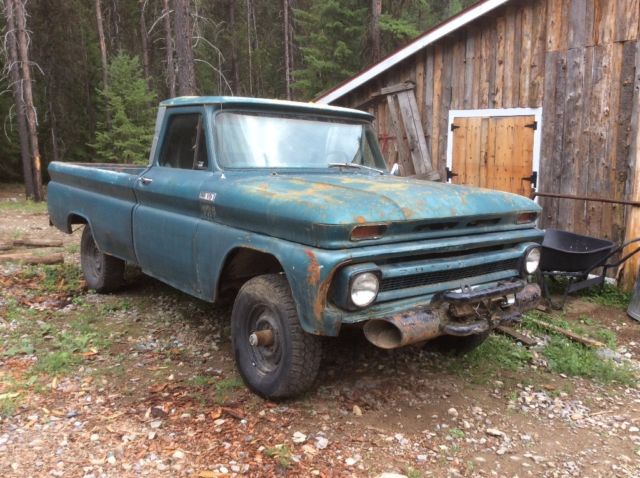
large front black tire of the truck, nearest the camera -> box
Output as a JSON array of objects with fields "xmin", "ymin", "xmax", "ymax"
[{"xmin": 231, "ymin": 274, "xmax": 322, "ymax": 399}]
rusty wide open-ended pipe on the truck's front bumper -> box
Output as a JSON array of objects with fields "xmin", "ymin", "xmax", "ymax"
[{"xmin": 364, "ymin": 311, "xmax": 442, "ymax": 349}]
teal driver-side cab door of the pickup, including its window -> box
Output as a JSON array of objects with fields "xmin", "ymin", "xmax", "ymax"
[{"xmin": 133, "ymin": 108, "xmax": 212, "ymax": 295}]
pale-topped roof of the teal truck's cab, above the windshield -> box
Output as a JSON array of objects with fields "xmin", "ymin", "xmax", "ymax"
[{"xmin": 160, "ymin": 96, "xmax": 373, "ymax": 120}]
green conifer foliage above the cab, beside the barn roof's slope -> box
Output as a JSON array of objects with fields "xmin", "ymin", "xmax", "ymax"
[{"xmin": 293, "ymin": 0, "xmax": 367, "ymax": 99}]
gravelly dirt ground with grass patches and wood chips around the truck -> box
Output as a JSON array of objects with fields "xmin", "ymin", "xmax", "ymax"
[{"xmin": 0, "ymin": 187, "xmax": 640, "ymax": 478}]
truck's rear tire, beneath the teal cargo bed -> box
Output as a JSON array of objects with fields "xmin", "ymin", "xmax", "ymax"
[{"xmin": 80, "ymin": 224, "xmax": 125, "ymax": 293}]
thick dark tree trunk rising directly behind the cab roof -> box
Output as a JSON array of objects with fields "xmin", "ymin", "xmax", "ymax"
[{"xmin": 175, "ymin": 0, "xmax": 196, "ymax": 96}]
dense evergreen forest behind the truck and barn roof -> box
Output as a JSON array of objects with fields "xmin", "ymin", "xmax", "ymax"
[{"xmin": 0, "ymin": 0, "xmax": 473, "ymax": 200}]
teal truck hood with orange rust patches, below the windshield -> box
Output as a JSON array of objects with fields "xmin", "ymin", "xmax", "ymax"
[{"xmin": 215, "ymin": 171, "xmax": 540, "ymax": 249}]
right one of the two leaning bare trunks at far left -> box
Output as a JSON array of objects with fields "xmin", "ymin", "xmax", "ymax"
[{"xmin": 14, "ymin": 0, "xmax": 44, "ymax": 201}]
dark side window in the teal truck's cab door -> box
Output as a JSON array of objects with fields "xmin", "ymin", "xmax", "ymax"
[{"xmin": 158, "ymin": 113, "xmax": 209, "ymax": 169}]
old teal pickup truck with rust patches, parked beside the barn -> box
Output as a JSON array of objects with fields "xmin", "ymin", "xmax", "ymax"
[{"xmin": 48, "ymin": 97, "xmax": 543, "ymax": 399}]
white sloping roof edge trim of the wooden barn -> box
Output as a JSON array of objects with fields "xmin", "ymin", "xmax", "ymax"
[{"xmin": 314, "ymin": 0, "xmax": 509, "ymax": 104}]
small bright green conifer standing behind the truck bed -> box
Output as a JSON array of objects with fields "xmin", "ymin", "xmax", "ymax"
[{"xmin": 93, "ymin": 53, "xmax": 156, "ymax": 164}]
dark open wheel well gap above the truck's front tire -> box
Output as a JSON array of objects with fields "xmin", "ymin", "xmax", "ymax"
[{"xmin": 217, "ymin": 248, "xmax": 283, "ymax": 299}]
